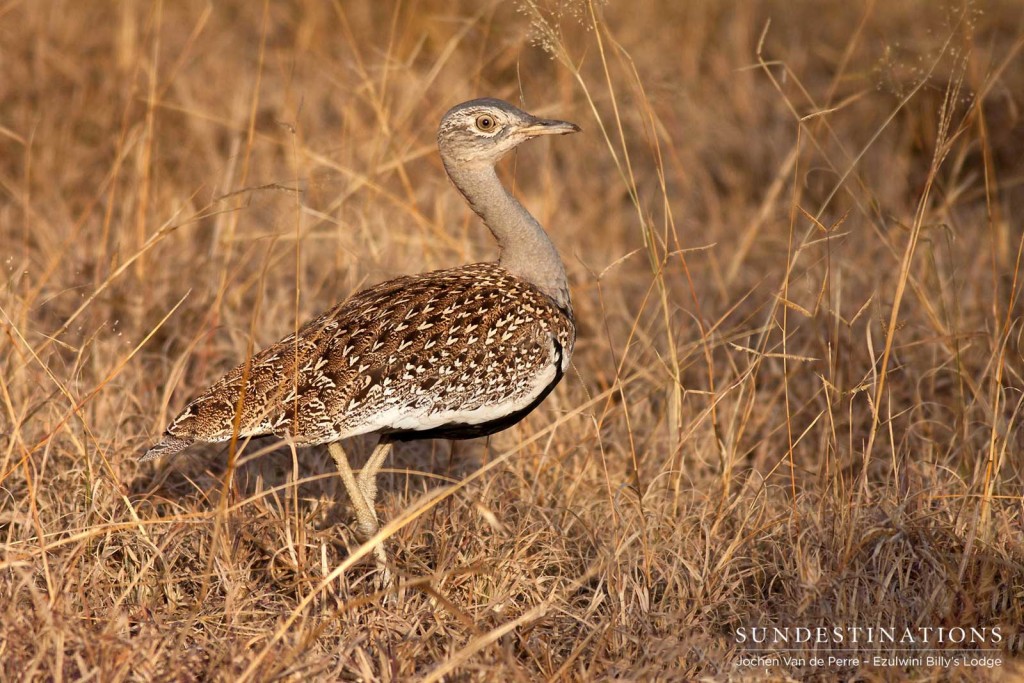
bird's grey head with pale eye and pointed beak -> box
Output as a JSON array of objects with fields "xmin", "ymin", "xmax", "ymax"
[{"xmin": 437, "ymin": 97, "xmax": 580, "ymax": 165}]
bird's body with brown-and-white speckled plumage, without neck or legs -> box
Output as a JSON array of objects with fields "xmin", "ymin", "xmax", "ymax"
[{"xmin": 146, "ymin": 263, "xmax": 575, "ymax": 458}]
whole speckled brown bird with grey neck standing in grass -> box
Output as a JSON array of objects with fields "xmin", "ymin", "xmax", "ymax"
[{"xmin": 141, "ymin": 97, "xmax": 581, "ymax": 583}]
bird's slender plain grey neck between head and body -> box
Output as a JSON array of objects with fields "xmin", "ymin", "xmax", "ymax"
[{"xmin": 444, "ymin": 160, "xmax": 571, "ymax": 310}]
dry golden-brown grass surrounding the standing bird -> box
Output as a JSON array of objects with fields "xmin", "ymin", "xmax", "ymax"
[{"xmin": 0, "ymin": 0, "xmax": 1024, "ymax": 681}]
